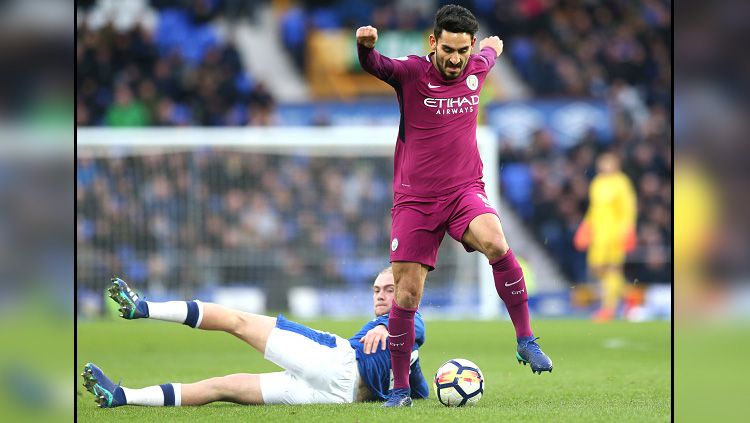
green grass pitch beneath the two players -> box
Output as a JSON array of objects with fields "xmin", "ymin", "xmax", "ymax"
[{"xmin": 76, "ymin": 319, "xmax": 671, "ymax": 423}]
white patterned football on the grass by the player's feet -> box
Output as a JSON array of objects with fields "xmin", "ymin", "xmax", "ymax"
[{"xmin": 434, "ymin": 358, "xmax": 484, "ymax": 407}]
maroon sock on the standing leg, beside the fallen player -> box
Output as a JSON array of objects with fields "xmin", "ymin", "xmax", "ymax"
[{"xmin": 388, "ymin": 299, "xmax": 417, "ymax": 389}]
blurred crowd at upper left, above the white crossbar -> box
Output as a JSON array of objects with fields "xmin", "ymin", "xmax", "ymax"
[{"xmin": 76, "ymin": 1, "xmax": 274, "ymax": 127}]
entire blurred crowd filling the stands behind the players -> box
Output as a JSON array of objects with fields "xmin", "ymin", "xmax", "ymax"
[{"xmin": 76, "ymin": 0, "xmax": 672, "ymax": 292}]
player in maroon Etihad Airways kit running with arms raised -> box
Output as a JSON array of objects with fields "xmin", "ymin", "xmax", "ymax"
[{"xmin": 357, "ymin": 5, "xmax": 552, "ymax": 407}]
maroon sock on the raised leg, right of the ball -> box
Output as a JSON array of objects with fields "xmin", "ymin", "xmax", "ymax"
[{"xmin": 490, "ymin": 250, "xmax": 532, "ymax": 338}]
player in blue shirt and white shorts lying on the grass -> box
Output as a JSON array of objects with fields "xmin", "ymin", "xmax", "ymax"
[{"xmin": 82, "ymin": 267, "xmax": 429, "ymax": 408}]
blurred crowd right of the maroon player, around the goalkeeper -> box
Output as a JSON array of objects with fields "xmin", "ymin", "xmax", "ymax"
[{"xmin": 488, "ymin": 0, "xmax": 672, "ymax": 282}]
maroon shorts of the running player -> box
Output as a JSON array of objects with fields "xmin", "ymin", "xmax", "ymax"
[{"xmin": 391, "ymin": 181, "xmax": 497, "ymax": 270}]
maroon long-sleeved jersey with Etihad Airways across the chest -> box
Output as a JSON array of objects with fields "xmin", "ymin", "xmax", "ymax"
[{"xmin": 357, "ymin": 44, "xmax": 497, "ymax": 197}]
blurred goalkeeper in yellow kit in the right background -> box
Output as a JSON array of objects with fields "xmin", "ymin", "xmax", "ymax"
[{"xmin": 573, "ymin": 153, "xmax": 637, "ymax": 321}]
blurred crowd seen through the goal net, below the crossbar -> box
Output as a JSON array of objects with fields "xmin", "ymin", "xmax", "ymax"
[{"xmin": 76, "ymin": 150, "xmax": 392, "ymax": 304}]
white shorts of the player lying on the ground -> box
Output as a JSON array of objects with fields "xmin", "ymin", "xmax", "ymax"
[{"xmin": 260, "ymin": 315, "xmax": 359, "ymax": 404}]
